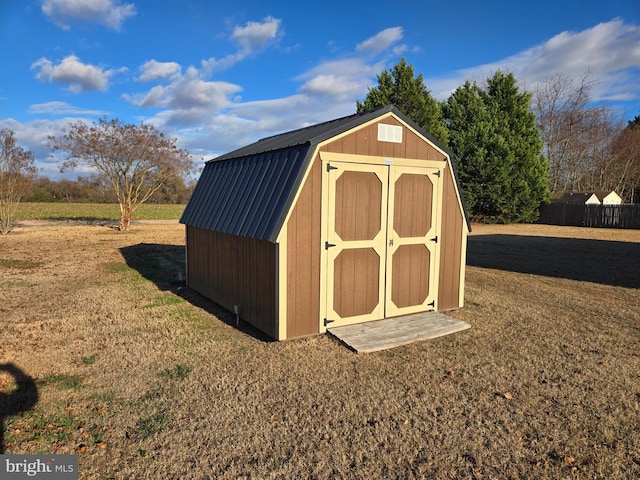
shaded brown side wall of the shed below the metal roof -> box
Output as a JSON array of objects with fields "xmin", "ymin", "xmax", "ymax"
[{"xmin": 186, "ymin": 226, "xmax": 278, "ymax": 338}]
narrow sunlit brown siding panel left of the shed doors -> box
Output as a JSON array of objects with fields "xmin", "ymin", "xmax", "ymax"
[{"xmin": 286, "ymin": 158, "xmax": 322, "ymax": 339}]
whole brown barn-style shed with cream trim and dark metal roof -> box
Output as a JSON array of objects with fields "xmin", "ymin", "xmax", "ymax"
[{"xmin": 180, "ymin": 106, "xmax": 469, "ymax": 340}]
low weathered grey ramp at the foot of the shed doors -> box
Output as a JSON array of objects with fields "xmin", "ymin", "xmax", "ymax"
[{"xmin": 328, "ymin": 312, "xmax": 471, "ymax": 353}]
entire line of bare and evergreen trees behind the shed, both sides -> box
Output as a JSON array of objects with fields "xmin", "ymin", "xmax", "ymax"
[{"xmin": 0, "ymin": 58, "xmax": 640, "ymax": 233}]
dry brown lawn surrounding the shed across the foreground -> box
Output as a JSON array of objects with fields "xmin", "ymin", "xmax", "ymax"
[{"xmin": 0, "ymin": 225, "xmax": 640, "ymax": 479}]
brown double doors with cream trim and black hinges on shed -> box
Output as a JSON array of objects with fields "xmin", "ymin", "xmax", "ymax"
[{"xmin": 325, "ymin": 162, "xmax": 440, "ymax": 326}]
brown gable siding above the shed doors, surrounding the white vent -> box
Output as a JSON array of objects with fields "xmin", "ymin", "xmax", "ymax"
[{"xmin": 321, "ymin": 117, "xmax": 444, "ymax": 160}]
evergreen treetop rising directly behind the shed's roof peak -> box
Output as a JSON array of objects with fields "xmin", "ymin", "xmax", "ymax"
[{"xmin": 356, "ymin": 58, "xmax": 447, "ymax": 145}]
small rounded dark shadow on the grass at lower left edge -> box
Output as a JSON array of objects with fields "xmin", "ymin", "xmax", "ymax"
[{"xmin": 0, "ymin": 363, "xmax": 39, "ymax": 454}]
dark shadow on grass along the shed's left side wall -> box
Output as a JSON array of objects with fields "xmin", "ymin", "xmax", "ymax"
[{"xmin": 120, "ymin": 243, "xmax": 273, "ymax": 342}]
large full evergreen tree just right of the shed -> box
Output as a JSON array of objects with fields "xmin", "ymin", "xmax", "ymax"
[{"xmin": 444, "ymin": 71, "xmax": 549, "ymax": 223}]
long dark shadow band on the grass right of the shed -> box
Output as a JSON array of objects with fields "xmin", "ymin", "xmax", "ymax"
[{"xmin": 467, "ymin": 234, "xmax": 640, "ymax": 288}]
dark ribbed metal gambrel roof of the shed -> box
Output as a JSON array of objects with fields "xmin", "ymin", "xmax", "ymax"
[{"xmin": 180, "ymin": 105, "xmax": 464, "ymax": 242}]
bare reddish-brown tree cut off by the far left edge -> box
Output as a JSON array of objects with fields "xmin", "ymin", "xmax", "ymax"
[{"xmin": 0, "ymin": 128, "xmax": 37, "ymax": 234}]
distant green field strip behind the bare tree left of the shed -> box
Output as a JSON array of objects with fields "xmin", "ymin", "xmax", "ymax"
[{"xmin": 15, "ymin": 202, "xmax": 185, "ymax": 221}]
